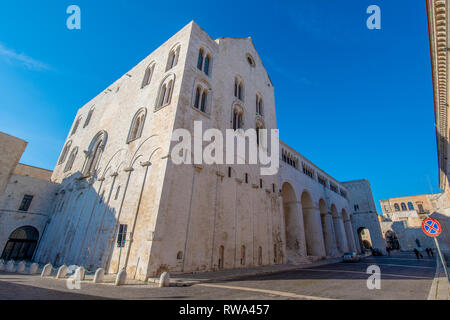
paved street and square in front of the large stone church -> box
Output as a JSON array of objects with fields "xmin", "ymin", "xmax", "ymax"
[{"xmin": 0, "ymin": 253, "xmax": 435, "ymax": 300}]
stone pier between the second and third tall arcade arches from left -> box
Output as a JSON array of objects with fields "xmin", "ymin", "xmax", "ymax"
[{"xmin": 303, "ymin": 207, "xmax": 326, "ymax": 257}]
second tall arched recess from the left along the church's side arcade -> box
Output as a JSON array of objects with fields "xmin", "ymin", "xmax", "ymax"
[{"xmin": 301, "ymin": 191, "xmax": 326, "ymax": 257}]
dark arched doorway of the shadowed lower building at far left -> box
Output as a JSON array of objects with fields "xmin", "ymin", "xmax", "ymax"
[{"xmin": 2, "ymin": 226, "xmax": 39, "ymax": 260}]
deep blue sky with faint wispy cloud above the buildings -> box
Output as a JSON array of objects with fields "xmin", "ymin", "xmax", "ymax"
[{"xmin": 0, "ymin": 0, "xmax": 438, "ymax": 214}]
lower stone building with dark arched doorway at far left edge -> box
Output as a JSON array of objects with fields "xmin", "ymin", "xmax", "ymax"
[{"xmin": 0, "ymin": 132, "xmax": 58, "ymax": 260}]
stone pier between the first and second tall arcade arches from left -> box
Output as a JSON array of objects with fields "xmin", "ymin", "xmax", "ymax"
[{"xmin": 283, "ymin": 201, "xmax": 306, "ymax": 256}]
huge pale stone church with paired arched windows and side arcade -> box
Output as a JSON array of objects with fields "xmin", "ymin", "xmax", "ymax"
[{"xmin": 25, "ymin": 22, "xmax": 376, "ymax": 280}]
